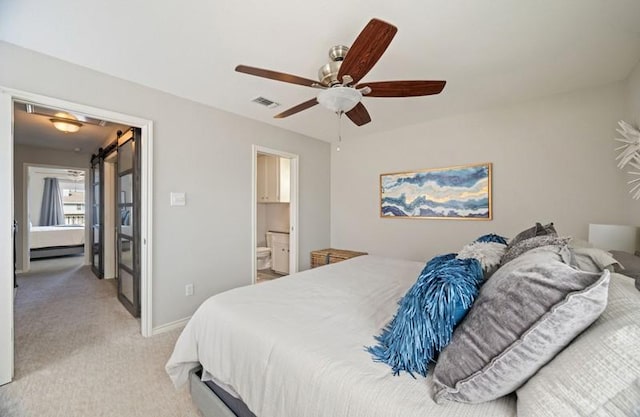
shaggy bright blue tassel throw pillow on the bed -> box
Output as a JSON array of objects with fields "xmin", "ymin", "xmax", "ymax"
[{"xmin": 367, "ymin": 254, "xmax": 483, "ymax": 377}]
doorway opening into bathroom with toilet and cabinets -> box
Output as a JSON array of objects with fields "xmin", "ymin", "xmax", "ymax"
[{"xmin": 252, "ymin": 145, "xmax": 299, "ymax": 283}]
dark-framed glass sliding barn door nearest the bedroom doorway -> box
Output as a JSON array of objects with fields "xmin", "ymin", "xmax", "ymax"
[{"xmin": 116, "ymin": 128, "xmax": 140, "ymax": 317}]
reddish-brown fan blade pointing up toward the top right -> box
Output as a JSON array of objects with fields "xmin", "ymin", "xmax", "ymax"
[{"xmin": 338, "ymin": 19, "xmax": 398, "ymax": 83}]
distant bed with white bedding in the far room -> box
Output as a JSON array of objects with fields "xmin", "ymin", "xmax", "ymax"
[{"xmin": 29, "ymin": 225, "xmax": 85, "ymax": 259}]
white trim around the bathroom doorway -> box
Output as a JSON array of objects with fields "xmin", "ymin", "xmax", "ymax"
[{"xmin": 251, "ymin": 145, "xmax": 300, "ymax": 284}]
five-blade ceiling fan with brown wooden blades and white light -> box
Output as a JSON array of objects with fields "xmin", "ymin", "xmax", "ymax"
[{"xmin": 236, "ymin": 19, "xmax": 446, "ymax": 126}]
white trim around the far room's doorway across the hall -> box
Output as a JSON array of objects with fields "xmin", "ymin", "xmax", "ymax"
[{"xmin": 18, "ymin": 162, "xmax": 91, "ymax": 272}]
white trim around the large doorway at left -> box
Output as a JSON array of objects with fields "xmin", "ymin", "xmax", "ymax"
[{"xmin": 0, "ymin": 86, "xmax": 155, "ymax": 385}]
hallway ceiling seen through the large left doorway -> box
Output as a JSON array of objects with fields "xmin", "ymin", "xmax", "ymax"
[{"xmin": 13, "ymin": 103, "xmax": 128, "ymax": 154}]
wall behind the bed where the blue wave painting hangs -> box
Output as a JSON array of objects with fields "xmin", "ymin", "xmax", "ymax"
[{"xmin": 331, "ymin": 83, "xmax": 629, "ymax": 260}]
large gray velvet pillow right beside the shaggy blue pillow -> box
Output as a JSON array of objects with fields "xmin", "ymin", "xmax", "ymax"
[{"xmin": 433, "ymin": 246, "xmax": 609, "ymax": 403}]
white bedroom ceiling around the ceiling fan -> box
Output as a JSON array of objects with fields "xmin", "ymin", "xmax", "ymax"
[{"xmin": 0, "ymin": 0, "xmax": 640, "ymax": 140}]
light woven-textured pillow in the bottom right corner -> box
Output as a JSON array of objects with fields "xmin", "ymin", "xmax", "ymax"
[{"xmin": 518, "ymin": 274, "xmax": 640, "ymax": 417}]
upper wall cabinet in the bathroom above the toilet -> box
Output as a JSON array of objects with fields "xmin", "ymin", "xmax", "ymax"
[{"xmin": 256, "ymin": 154, "xmax": 290, "ymax": 203}]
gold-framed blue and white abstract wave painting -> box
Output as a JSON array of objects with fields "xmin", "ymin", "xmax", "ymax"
[{"xmin": 380, "ymin": 163, "xmax": 492, "ymax": 220}]
